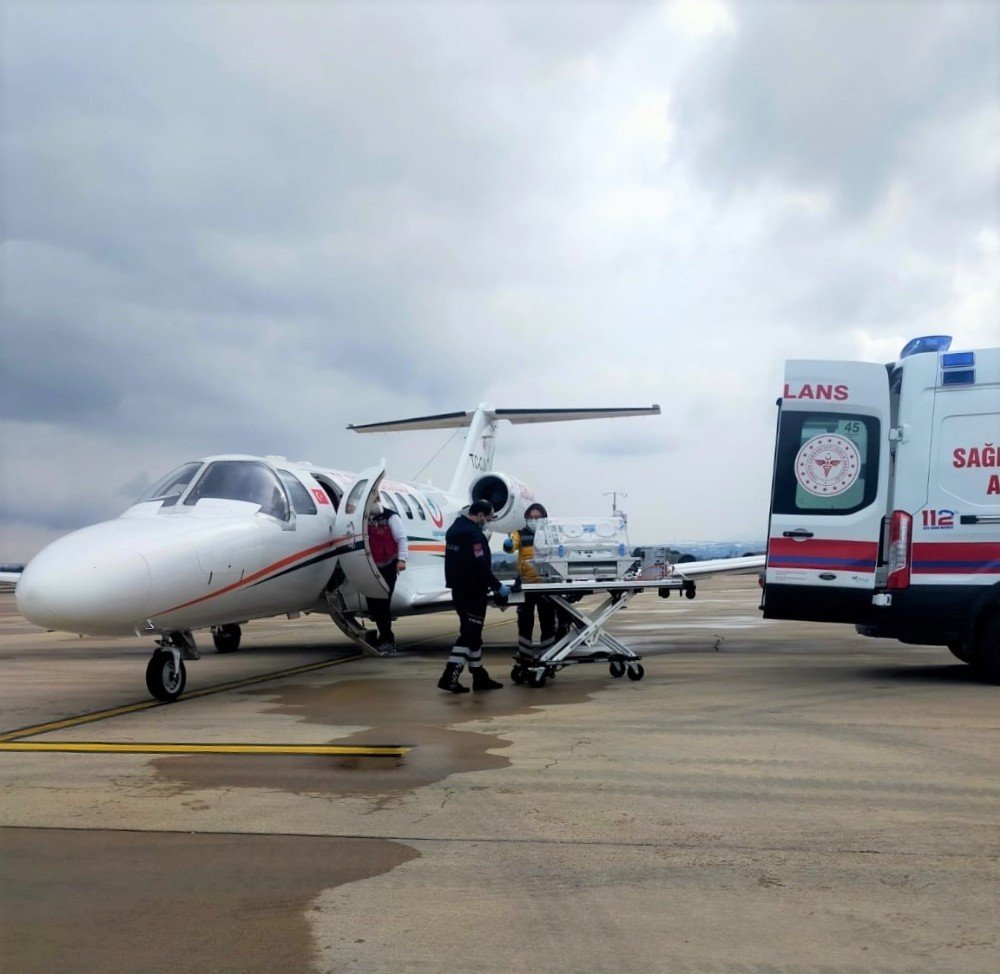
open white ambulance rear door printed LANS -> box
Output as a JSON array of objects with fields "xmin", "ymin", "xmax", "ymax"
[{"xmin": 763, "ymin": 360, "xmax": 890, "ymax": 622}]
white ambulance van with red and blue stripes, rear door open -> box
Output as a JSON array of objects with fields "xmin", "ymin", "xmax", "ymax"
[{"xmin": 761, "ymin": 335, "xmax": 1000, "ymax": 679}]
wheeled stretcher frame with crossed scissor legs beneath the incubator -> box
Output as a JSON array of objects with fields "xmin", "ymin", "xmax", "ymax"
[{"xmin": 510, "ymin": 573, "xmax": 695, "ymax": 687}]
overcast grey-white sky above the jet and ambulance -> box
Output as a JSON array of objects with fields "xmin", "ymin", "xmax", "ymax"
[{"xmin": 0, "ymin": 0, "xmax": 1000, "ymax": 561}]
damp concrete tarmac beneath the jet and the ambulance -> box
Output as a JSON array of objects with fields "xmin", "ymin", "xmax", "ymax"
[{"xmin": 0, "ymin": 576, "xmax": 1000, "ymax": 974}]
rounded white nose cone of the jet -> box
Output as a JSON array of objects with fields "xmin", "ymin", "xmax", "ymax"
[{"xmin": 15, "ymin": 531, "xmax": 150, "ymax": 635}]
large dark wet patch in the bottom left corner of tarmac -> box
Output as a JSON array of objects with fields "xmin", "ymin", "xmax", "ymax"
[{"xmin": 0, "ymin": 829, "xmax": 419, "ymax": 974}]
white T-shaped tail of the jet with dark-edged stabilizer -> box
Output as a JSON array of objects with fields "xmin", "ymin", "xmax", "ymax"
[{"xmin": 347, "ymin": 403, "xmax": 660, "ymax": 496}]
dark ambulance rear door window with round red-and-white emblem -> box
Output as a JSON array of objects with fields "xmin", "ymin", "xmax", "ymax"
[{"xmin": 773, "ymin": 411, "xmax": 880, "ymax": 515}]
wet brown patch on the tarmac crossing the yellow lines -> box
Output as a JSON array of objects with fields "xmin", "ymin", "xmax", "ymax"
[{"xmin": 151, "ymin": 660, "xmax": 608, "ymax": 810}]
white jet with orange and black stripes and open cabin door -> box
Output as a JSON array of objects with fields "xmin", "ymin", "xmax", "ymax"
[{"xmin": 16, "ymin": 405, "xmax": 672, "ymax": 701}]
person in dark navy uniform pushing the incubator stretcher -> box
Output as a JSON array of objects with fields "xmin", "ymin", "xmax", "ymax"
[{"xmin": 438, "ymin": 501, "xmax": 510, "ymax": 693}]
